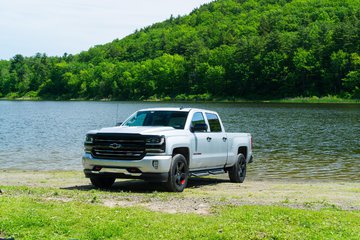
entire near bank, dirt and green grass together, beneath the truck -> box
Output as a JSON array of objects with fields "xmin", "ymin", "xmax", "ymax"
[{"xmin": 0, "ymin": 170, "xmax": 360, "ymax": 240}]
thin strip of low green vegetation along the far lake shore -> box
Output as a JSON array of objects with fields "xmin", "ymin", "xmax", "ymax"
[{"xmin": 0, "ymin": 95, "xmax": 360, "ymax": 104}]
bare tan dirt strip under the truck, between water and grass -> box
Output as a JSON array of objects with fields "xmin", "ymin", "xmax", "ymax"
[{"xmin": 0, "ymin": 170, "xmax": 360, "ymax": 214}]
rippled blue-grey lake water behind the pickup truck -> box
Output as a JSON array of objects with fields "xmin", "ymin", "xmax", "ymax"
[{"xmin": 0, "ymin": 101, "xmax": 360, "ymax": 181}]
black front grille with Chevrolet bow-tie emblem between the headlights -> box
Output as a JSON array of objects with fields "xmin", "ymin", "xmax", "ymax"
[{"xmin": 91, "ymin": 133, "xmax": 146, "ymax": 160}]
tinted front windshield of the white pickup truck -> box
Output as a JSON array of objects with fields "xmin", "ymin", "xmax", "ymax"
[{"xmin": 123, "ymin": 111, "xmax": 189, "ymax": 129}]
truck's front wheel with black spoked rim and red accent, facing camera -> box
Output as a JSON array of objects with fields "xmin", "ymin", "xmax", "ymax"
[{"xmin": 165, "ymin": 154, "xmax": 189, "ymax": 192}]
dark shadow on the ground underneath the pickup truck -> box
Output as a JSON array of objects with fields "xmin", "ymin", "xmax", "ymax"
[{"xmin": 61, "ymin": 177, "xmax": 229, "ymax": 193}]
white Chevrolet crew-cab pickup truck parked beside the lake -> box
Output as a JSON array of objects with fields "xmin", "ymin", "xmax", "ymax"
[{"xmin": 82, "ymin": 108, "xmax": 252, "ymax": 192}]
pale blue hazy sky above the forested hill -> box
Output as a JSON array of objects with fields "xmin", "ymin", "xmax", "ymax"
[{"xmin": 0, "ymin": 0, "xmax": 211, "ymax": 59}]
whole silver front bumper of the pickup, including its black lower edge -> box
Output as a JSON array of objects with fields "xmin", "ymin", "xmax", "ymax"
[{"xmin": 82, "ymin": 153, "xmax": 172, "ymax": 182}]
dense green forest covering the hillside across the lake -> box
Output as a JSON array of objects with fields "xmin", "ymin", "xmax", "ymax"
[{"xmin": 0, "ymin": 0, "xmax": 360, "ymax": 100}]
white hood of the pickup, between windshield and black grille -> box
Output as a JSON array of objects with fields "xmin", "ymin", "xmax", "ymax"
[{"xmin": 88, "ymin": 126, "xmax": 179, "ymax": 135}]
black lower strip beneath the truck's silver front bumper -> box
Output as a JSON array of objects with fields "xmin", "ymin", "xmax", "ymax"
[{"xmin": 84, "ymin": 169, "xmax": 169, "ymax": 182}]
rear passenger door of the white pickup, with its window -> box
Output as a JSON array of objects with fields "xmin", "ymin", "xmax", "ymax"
[{"xmin": 205, "ymin": 113, "xmax": 227, "ymax": 167}]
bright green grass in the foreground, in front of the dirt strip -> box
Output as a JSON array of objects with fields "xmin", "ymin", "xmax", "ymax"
[{"xmin": 0, "ymin": 186, "xmax": 360, "ymax": 239}]
